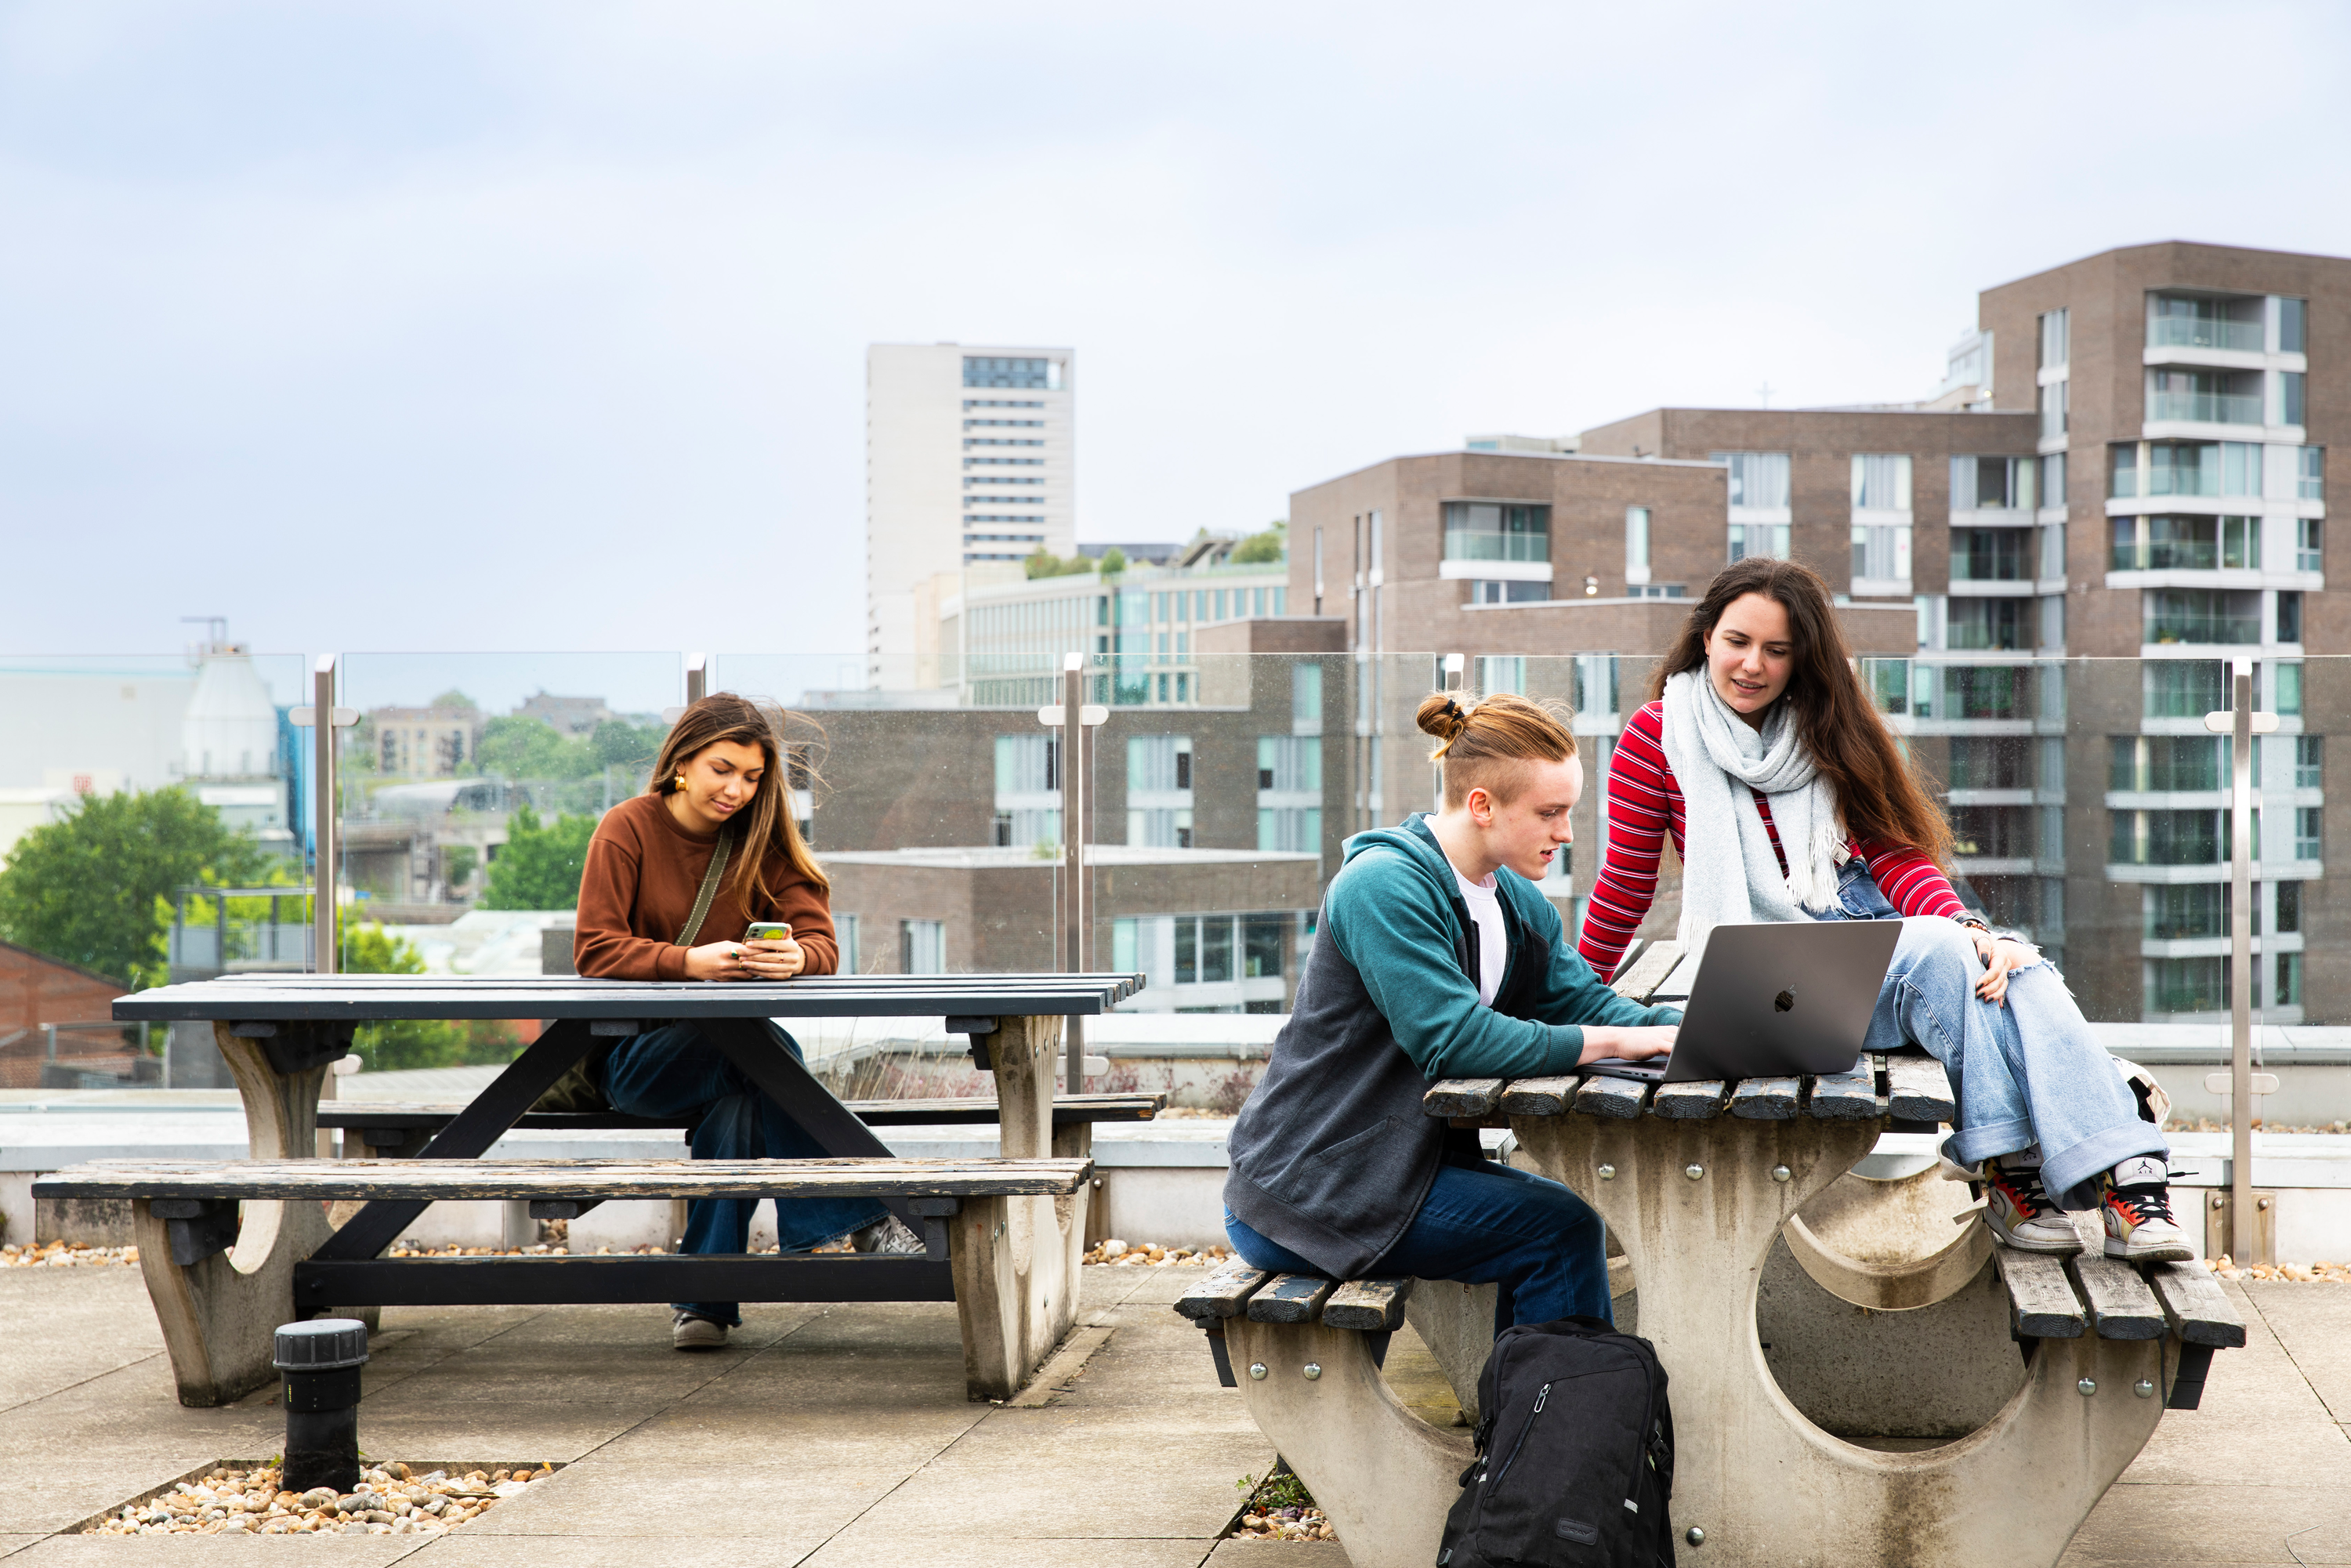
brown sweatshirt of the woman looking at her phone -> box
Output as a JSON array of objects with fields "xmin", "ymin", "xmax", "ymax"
[{"xmin": 571, "ymin": 795, "xmax": 842, "ymax": 980}]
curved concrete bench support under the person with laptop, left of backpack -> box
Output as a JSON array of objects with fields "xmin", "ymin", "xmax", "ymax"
[{"xmin": 1225, "ymin": 1326, "xmax": 1493, "ymax": 1568}]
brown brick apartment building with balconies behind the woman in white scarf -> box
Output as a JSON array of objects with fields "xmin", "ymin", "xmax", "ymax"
[{"xmin": 1291, "ymin": 242, "xmax": 2351, "ymax": 1023}]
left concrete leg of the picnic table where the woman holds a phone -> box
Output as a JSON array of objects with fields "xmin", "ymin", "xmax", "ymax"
[{"xmin": 134, "ymin": 1023, "xmax": 334, "ymax": 1408}]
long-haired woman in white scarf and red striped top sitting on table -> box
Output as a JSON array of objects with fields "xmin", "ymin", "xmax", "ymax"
[{"xmin": 1578, "ymin": 559, "xmax": 2191, "ymax": 1262}]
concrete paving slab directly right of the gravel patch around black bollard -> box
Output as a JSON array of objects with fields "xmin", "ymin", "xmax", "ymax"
[{"xmin": 465, "ymin": 1450, "xmax": 903, "ymax": 1552}]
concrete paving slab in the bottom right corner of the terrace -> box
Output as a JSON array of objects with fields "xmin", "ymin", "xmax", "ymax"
[{"xmin": 2057, "ymin": 1483, "xmax": 2351, "ymax": 1568}]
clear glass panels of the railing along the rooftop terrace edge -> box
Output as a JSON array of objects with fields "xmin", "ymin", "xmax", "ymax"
[{"xmin": 0, "ymin": 639, "xmax": 2351, "ymax": 1081}]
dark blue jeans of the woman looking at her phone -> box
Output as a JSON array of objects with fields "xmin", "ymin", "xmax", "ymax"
[{"xmin": 604, "ymin": 1023, "xmax": 889, "ymax": 1326}]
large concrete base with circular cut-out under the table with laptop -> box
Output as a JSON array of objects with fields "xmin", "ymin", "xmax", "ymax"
[{"xmin": 1514, "ymin": 1117, "xmax": 2168, "ymax": 1568}]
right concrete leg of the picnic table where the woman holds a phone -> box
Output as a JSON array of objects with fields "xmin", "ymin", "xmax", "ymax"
[{"xmin": 955, "ymin": 1018, "xmax": 1089, "ymax": 1399}]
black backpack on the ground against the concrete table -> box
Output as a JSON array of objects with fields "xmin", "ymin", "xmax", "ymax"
[{"xmin": 1436, "ymin": 1316, "xmax": 1674, "ymax": 1568}]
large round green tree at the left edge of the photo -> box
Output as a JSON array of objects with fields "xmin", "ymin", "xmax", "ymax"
[{"xmin": 0, "ymin": 788, "xmax": 270, "ymax": 985}]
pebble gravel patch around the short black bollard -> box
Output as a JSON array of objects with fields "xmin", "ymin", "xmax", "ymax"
[{"xmin": 82, "ymin": 1460, "xmax": 555, "ymax": 1535}]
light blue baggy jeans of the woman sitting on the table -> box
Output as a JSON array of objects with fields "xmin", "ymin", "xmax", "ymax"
[{"xmin": 1815, "ymin": 856, "xmax": 2170, "ymax": 1208}]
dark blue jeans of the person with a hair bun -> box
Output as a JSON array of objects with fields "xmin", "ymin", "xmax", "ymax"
[{"xmin": 1225, "ymin": 1159, "xmax": 1615, "ymax": 1333}]
